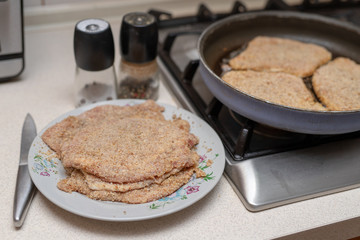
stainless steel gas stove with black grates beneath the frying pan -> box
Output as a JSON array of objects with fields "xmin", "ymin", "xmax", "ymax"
[{"xmin": 149, "ymin": 0, "xmax": 360, "ymax": 211}]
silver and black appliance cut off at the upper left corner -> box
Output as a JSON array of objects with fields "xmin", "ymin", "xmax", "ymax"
[{"xmin": 0, "ymin": 0, "xmax": 24, "ymax": 82}]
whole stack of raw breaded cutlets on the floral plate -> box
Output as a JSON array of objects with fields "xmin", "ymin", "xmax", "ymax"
[{"xmin": 42, "ymin": 100, "xmax": 203, "ymax": 203}]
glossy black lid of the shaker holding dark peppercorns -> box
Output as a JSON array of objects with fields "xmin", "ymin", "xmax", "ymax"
[{"xmin": 120, "ymin": 12, "xmax": 158, "ymax": 63}]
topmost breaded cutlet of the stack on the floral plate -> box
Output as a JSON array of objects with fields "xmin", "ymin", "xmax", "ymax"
[{"xmin": 61, "ymin": 118, "xmax": 199, "ymax": 183}]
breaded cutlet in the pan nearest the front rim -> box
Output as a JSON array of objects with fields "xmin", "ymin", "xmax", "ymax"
[{"xmin": 222, "ymin": 71, "xmax": 325, "ymax": 111}]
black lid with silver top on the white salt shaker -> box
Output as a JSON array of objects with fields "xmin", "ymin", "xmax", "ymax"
[{"xmin": 74, "ymin": 19, "xmax": 115, "ymax": 71}]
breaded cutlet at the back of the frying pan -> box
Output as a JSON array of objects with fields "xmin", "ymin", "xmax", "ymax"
[{"xmin": 229, "ymin": 36, "xmax": 331, "ymax": 77}]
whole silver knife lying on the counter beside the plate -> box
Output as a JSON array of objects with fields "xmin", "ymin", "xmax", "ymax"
[{"xmin": 13, "ymin": 113, "xmax": 36, "ymax": 228}]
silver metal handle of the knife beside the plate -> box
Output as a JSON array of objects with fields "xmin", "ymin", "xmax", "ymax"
[{"xmin": 14, "ymin": 164, "xmax": 35, "ymax": 227}]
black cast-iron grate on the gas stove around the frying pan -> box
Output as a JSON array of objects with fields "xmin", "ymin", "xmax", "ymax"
[{"xmin": 150, "ymin": 0, "xmax": 360, "ymax": 161}]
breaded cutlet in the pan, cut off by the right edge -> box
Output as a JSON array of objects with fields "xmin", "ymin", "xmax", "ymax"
[{"xmin": 312, "ymin": 57, "xmax": 360, "ymax": 111}]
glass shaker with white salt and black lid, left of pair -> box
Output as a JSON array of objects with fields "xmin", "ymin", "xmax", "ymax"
[{"xmin": 74, "ymin": 19, "xmax": 116, "ymax": 107}]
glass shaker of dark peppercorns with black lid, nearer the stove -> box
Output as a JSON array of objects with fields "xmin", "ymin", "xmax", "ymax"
[{"xmin": 117, "ymin": 12, "xmax": 160, "ymax": 100}]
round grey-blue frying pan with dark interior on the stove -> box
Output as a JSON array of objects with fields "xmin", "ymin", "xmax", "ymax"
[{"xmin": 198, "ymin": 11, "xmax": 360, "ymax": 134}]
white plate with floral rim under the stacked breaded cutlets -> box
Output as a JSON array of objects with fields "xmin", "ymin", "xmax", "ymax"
[{"xmin": 28, "ymin": 100, "xmax": 225, "ymax": 221}]
